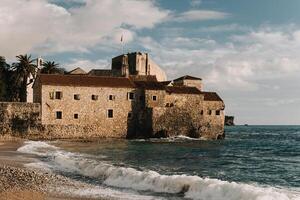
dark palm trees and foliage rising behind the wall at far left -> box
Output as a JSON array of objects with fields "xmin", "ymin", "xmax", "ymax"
[{"xmin": 0, "ymin": 54, "xmax": 65, "ymax": 102}]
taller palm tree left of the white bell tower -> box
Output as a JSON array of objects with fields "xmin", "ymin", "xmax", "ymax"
[{"xmin": 12, "ymin": 54, "xmax": 37, "ymax": 102}]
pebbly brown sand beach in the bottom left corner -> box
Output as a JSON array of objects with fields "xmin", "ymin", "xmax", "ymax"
[{"xmin": 0, "ymin": 138, "xmax": 107, "ymax": 200}]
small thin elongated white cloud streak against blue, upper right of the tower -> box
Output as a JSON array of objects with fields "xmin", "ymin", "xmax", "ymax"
[{"xmin": 170, "ymin": 10, "xmax": 230, "ymax": 22}]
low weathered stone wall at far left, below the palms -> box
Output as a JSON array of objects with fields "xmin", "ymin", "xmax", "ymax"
[{"xmin": 0, "ymin": 102, "xmax": 41, "ymax": 135}]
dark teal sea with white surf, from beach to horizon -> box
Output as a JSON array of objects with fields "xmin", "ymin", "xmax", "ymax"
[{"xmin": 18, "ymin": 125, "xmax": 300, "ymax": 200}]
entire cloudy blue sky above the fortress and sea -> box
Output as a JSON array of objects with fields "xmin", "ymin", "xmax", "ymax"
[{"xmin": 0, "ymin": 0, "xmax": 300, "ymax": 125}]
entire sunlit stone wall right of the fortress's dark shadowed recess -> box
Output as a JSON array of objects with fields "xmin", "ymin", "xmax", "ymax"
[{"xmin": 148, "ymin": 94, "xmax": 224, "ymax": 139}]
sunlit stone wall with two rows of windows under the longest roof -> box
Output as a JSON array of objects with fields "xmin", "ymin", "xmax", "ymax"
[{"xmin": 36, "ymin": 85, "xmax": 135, "ymax": 137}]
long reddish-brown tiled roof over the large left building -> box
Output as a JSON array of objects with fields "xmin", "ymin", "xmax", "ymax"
[{"xmin": 39, "ymin": 74, "xmax": 134, "ymax": 88}]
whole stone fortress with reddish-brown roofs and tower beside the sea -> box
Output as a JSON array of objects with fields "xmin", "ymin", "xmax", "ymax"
[{"xmin": 0, "ymin": 52, "xmax": 225, "ymax": 139}]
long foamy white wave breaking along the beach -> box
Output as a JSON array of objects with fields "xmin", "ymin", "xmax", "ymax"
[{"xmin": 18, "ymin": 141, "xmax": 300, "ymax": 200}]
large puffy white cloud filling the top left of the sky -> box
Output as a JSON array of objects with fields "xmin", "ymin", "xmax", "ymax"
[{"xmin": 0, "ymin": 0, "xmax": 169, "ymax": 58}]
